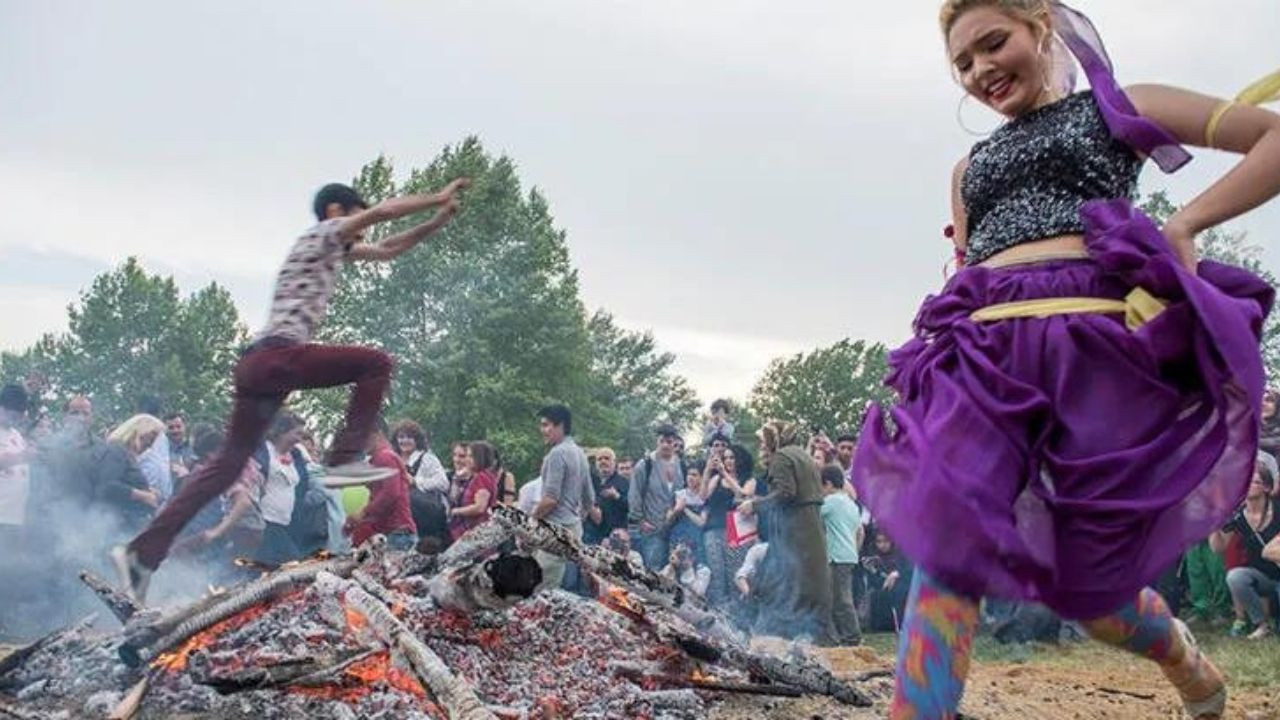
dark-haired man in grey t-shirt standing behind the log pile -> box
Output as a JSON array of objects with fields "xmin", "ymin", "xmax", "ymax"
[{"xmin": 534, "ymin": 405, "xmax": 595, "ymax": 588}]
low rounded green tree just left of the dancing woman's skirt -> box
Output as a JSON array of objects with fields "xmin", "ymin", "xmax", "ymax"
[{"xmin": 750, "ymin": 340, "xmax": 892, "ymax": 438}]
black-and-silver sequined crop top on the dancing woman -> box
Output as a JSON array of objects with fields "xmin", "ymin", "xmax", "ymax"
[{"xmin": 960, "ymin": 91, "xmax": 1142, "ymax": 265}]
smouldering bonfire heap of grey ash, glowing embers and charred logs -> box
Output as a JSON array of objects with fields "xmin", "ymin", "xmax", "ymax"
[{"xmin": 0, "ymin": 509, "xmax": 882, "ymax": 720}]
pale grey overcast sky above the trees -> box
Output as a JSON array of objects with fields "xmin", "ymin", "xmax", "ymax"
[{"xmin": 0, "ymin": 0, "xmax": 1280, "ymax": 401}]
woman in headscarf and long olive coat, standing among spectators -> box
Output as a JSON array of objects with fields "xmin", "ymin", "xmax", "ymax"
[{"xmin": 739, "ymin": 421, "xmax": 831, "ymax": 644}]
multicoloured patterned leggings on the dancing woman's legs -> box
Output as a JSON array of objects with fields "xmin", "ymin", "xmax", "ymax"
[{"xmin": 890, "ymin": 571, "xmax": 1187, "ymax": 720}]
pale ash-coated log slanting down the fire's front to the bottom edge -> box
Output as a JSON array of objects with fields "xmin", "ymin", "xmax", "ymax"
[{"xmin": 323, "ymin": 577, "xmax": 494, "ymax": 720}]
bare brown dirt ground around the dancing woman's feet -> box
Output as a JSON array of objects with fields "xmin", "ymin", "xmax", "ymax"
[{"xmin": 712, "ymin": 635, "xmax": 1280, "ymax": 720}]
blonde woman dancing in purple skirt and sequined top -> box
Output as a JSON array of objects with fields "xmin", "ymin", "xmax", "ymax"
[{"xmin": 854, "ymin": 0, "xmax": 1280, "ymax": 719}]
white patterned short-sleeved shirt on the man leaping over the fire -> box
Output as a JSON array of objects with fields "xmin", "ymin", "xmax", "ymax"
[{"xmin": 257, "ymin": 218, "xmax": 351, "ymax": 343}]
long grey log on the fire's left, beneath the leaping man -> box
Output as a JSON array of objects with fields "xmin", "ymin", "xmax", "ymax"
[{"xmin": 119, "ymin": 559, "xmax": 358, "ymax": 667}]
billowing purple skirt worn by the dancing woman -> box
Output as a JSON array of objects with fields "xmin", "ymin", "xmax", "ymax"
[{"xmin": 854, "ymin": 201, "xmax": 1274, "ymax": 619}]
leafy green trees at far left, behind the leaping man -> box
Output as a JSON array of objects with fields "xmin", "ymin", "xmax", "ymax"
[{"xmin": 0, "ymin": 258, "xmax": 246, "ymax": 421}]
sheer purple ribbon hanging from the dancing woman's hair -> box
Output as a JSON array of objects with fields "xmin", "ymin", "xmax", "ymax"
[{"xmin": 1052, "ymin": 0, "xmax": 1192, "ymax": 173}]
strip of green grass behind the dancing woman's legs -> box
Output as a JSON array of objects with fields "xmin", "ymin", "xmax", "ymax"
[{"xmin": 863, "ymin": 632, "xmax": 1280, "ymax": 691}]
